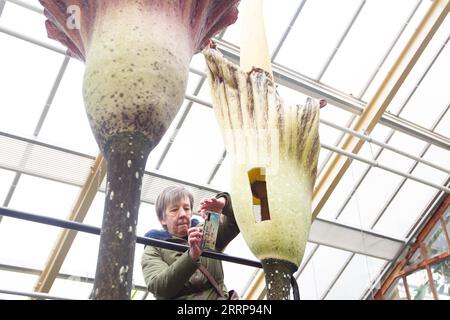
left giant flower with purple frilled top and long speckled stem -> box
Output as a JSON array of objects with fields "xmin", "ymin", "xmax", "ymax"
[{"xmin": 40, "ymin": 0, "xmax": 238, "ymax": 299}]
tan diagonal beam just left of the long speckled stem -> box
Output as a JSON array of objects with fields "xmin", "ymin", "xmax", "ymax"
[{"xmin": 34, "ymin": 154, "xmax": 106, "ymax": 292}]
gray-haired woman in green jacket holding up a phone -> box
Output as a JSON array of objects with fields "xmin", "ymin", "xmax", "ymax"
[{"xmin": 141, "ymin": 186, "xmax": 239, "ymax": 300}]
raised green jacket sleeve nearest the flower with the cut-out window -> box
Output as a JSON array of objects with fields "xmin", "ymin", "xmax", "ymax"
[{"xmin": 216, "ymin": 192, "xmax": 240, "ymax": 251}]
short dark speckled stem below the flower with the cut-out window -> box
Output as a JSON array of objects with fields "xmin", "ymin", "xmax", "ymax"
[{"xmin": 261, "ymin": 259, "xmax": 297, "ymax": 300}]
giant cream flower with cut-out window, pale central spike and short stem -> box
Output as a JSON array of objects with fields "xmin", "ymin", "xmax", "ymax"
[{"xmin": 203, "ymin": 0, "xmax": 322, "ymax": 299}]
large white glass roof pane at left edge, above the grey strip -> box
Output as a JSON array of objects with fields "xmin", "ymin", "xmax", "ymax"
[{"xmin": 0, "ymin": 32, "xmax": 63, "ymax": 135}]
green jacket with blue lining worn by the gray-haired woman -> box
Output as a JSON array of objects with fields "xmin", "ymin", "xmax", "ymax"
[{"xmin": 141, "ymin": 193, "xmax": 239, "ymax": 300}]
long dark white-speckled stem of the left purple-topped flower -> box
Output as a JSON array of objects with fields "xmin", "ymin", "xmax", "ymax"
[{"xmin": 94, "ymin": 133, "xmax": 153, "ymax": 300}]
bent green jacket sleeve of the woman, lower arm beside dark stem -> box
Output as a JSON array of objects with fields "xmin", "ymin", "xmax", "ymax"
[{"xmin": 141, "ymin": 246, "xmax": 199, "ymax": 299}]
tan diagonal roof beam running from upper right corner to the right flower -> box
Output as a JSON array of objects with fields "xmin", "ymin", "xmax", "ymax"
[{"xmin": 312, "ymin": 0, "xmax": 450, "ymax": 218}]
